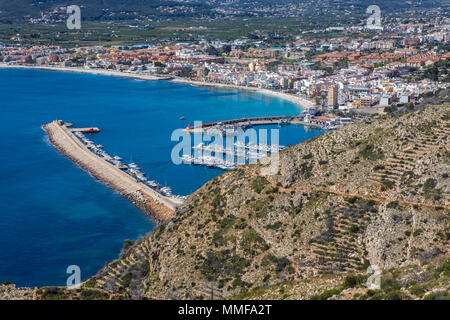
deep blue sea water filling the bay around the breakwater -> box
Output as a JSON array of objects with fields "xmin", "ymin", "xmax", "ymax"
[{"xmin": 0, "ymin": 69, "xmax": 321, "ymax": 286}]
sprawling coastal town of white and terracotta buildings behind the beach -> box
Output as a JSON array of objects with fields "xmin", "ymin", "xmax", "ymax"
[{"xmin": 0, "ymin": 15, "xmax": 450, "ymax": 125}]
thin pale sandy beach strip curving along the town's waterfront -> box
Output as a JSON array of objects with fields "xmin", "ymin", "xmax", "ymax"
[{"xmin": 0, "ymin": 63, "xmax": 315, "ymax": 109}]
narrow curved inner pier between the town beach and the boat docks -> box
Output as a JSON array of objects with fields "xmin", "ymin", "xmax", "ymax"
[{"xmin": 184, "ymin": 116, "xmax": 322, "ymax": 133}]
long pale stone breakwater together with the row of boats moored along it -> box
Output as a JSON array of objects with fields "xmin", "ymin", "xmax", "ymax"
[{"xmin": 43, "ymin": 120, "xmax": 184, "ymax": 222}]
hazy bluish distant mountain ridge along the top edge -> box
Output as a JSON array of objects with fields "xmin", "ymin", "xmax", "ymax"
[{"xmin": 0, "ymin": 0, "xmax": 445, "ymax": 23}]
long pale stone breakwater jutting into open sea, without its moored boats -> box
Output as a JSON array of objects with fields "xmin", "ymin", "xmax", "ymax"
[{"xmin": 43, "ymin": 120, "xmax": 183, "ymax": 222}]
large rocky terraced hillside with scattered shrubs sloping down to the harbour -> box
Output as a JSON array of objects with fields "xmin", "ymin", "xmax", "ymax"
[{"xmin": 77, "ymin": 104, "xmax": 450, "ymax": 299}]
